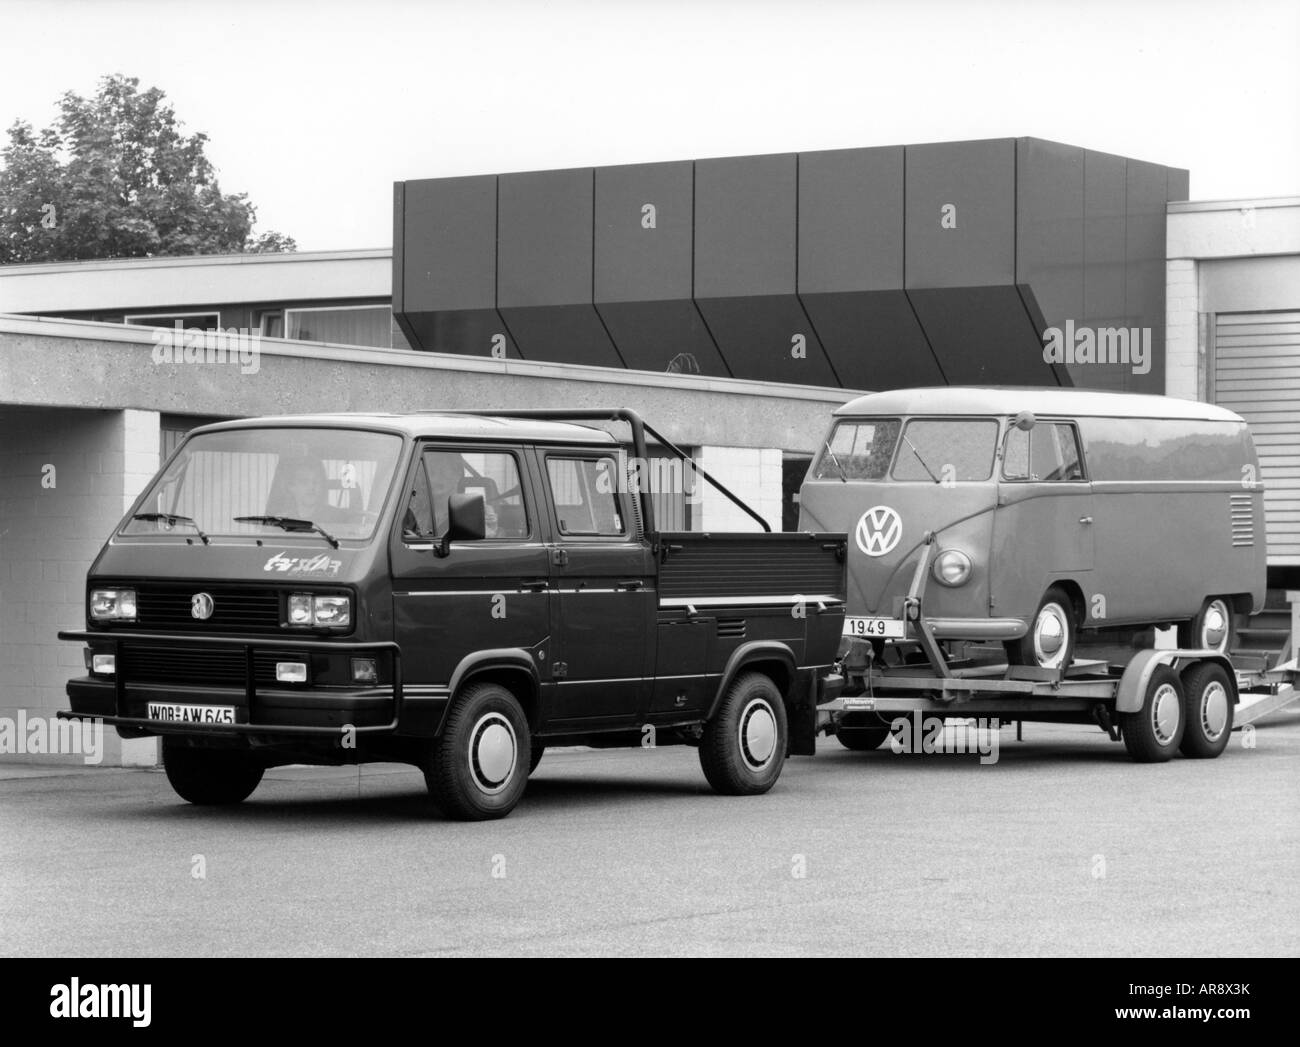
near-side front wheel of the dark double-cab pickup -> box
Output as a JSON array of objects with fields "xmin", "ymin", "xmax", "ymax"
[{"xmin": 424, "ymin": 683, "xmax": 532, "ymax": 822}]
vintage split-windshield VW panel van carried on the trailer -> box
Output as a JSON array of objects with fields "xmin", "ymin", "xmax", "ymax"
[{"xmin": 800, "ymin": 386, "xmax": 1265, "ymax": 669}]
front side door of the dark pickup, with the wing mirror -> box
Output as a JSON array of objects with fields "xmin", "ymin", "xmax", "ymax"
[{"xmin": 389, "ymin": 444, "xmax": 551, "ymax": 695}]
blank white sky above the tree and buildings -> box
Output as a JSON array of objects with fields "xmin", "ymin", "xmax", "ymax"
[{"xmin": 0, "ymin": 0, "xmax": 1300, "ymax": 250}]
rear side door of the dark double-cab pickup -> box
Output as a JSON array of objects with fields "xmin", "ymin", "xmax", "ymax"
[{"xmin": 538, "ymin": 447, "xmax": 655, "ymax": 727}]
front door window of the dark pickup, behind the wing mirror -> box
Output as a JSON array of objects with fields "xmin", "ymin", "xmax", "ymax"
[{"xmin": 402, "ymin": 450, "xmax": 530, "ymax": 538}]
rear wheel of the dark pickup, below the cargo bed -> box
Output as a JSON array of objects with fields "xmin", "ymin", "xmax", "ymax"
[{"xmin": 699, "ymin": 672, "xmax": 787, "ymax": 796}]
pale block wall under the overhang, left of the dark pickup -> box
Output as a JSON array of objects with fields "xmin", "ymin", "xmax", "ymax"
[{"xmin": 0, "ymin": 407, "xmax": 159, "ymax": 765}]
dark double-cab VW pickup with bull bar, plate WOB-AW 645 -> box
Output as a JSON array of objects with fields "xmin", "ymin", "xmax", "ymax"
[{"xmin": 60, "ymin": 411, "xmax": 845, "ymax": 819}]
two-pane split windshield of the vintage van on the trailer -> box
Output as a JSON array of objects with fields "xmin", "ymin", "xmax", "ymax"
[{"xmin": 813, "ymin": 417, "xmax": 998, "ymax": 484}]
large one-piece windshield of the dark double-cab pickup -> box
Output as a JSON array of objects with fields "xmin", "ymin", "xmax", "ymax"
[{"xmin": 121, "ymin": 428, "xmax": 402, "ymax": 538}]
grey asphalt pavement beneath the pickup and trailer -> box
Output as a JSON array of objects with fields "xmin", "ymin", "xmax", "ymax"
[{"xmin": 0, "ymin": 708, "xmax": 1300, "ymax": 956}]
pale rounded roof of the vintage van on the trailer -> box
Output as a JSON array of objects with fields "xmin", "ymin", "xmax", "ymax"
[{"xmin": 835, "ymin": 385, "xmax": 1242, "ymax": 421}]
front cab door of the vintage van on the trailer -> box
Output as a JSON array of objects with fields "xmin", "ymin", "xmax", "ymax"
[{"xmin": 989, "ymin": 419, "xmax": 1095, "ymax": 620}]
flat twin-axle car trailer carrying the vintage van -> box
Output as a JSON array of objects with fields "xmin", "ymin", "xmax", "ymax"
[{"xmin": 819, "ymin": 533, "xmax": 1300, "ymax": 763}]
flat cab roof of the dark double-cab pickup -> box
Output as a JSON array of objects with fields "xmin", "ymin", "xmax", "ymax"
[{"xmin": 193, "ymin": 411, "xmax": 616, "ymax": 445}]
